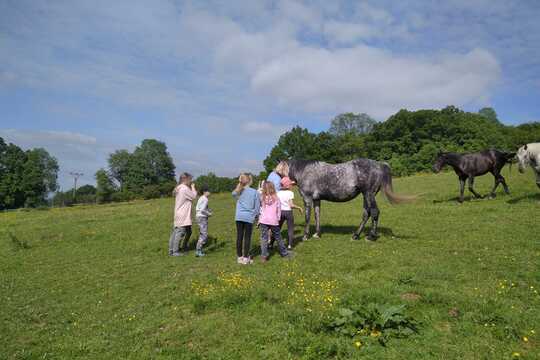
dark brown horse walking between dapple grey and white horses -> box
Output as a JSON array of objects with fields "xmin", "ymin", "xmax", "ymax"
[{"xmin": 433, "ymin": 149, "xmax": 516, "ymax": 202}]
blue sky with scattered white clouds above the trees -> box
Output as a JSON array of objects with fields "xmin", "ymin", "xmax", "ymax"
[{"xmin": 0, "ymin": 0, "xmax": 540, "ymax": 190}]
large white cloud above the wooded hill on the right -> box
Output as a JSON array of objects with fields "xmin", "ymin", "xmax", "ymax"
[{"xmin": 251, "ymin": 46, "xmax": 500, "ymax": 118}]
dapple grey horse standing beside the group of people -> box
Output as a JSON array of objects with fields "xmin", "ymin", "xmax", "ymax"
[{"xmin": 287, "ymin": 158, "xmax": 414, "ymax": 240}]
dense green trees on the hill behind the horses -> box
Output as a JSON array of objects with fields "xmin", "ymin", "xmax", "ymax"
[{"xmin": 264, "ymin": 106, "xmax": 540, "ymax": 176}]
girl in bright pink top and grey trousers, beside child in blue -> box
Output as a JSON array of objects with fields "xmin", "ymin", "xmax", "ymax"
[{"xmin": 259, "ymin": 181, "xmax": 292, "ymax": 262}]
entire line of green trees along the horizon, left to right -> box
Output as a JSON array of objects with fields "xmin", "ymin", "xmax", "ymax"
[{"xmin": 0, "ymin": 106, "xmax": 540, "ymax": 210}]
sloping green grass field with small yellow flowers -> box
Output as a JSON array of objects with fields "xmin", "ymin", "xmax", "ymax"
[{"xmin": 0, "ymin": 169, "xmax": 540, "ymax": 359}]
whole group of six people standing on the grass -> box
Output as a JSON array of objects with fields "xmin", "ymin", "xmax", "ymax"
[{"xmin": 169, "ymin": 165, "xmax": 303, "ymax": 265}]
